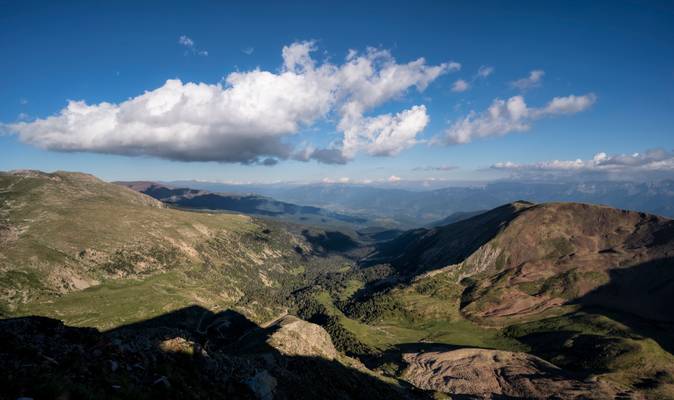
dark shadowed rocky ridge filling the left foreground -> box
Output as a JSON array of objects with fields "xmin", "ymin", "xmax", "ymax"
[{"xmin": 0, "ymin": 306, "xmax": 417, "ymax": 399}]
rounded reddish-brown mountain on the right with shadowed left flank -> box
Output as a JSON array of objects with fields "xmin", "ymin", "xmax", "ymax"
[{"xmin": 362, "ymin": 202, "xmax": 674, "ymax": 325}]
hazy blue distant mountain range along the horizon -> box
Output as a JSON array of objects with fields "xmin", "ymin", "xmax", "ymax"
[{"xmin": 171, "ymin": 180, "xmax": 674, "ymax": 228}]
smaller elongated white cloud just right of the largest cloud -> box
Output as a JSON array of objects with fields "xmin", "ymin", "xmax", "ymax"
[{"xmin": 443, "ymin": 93, "xmax": 597, "ymax": 144}]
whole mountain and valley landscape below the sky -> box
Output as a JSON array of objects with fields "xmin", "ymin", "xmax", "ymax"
[{"xmin": 0, "ymin": 171, "xmax": 674, "ymax": 399}]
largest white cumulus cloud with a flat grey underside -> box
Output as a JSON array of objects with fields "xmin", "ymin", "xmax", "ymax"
[{"xmin": 5, "ymin": 41, "xmax": 450, "ymax": 165}]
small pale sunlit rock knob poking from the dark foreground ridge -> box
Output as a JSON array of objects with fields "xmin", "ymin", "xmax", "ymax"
[{"xmin": 267, "ymin": 315, "xmax": 337, "ymax": 360}]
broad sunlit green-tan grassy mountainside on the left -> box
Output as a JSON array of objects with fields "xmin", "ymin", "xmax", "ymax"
[{"xmin": 0, "ymin": 171, "xmax": 352, "ymax": 328}]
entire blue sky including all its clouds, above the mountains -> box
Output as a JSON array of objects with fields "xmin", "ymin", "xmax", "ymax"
[{"xmin": 0, "ymin": 1, "xmax": 674, "ymax": 182}]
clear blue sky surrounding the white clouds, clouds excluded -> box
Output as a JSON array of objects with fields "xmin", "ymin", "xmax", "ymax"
[{"xmin": 0, "ymin": 1, "xmax": 674, "ymax": 182}]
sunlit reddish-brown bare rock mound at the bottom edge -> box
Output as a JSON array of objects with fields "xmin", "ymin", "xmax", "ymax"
[{"xmin": 403, "ymin": 349, "xmax": 616, "ymax": 399}]
